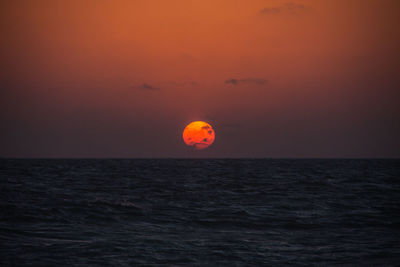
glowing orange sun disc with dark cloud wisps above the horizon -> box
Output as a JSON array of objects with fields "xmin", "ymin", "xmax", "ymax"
[{"xmin": 183, "ymin": 121, "xmax": 215, "ymax": 150}]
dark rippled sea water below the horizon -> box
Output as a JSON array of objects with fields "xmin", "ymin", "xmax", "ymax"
[{"xmin": 0, "ymin": 159, "xmax": 400, "ymax": 266}]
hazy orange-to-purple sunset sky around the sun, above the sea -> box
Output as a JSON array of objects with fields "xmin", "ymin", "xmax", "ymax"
[{"xmin": 0, "ymin": 0, "xmax": 400, "ymax": 158}]
